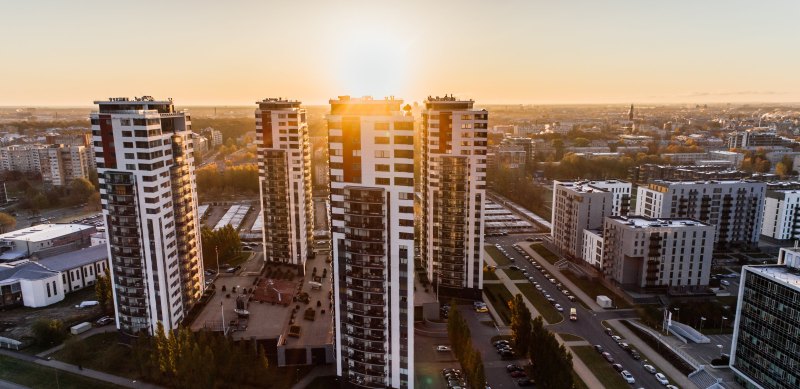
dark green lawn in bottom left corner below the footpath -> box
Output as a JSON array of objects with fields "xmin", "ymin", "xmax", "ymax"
[{"xmin": 0, "ymin": 355, "xmax": 120, "ymax": 389}]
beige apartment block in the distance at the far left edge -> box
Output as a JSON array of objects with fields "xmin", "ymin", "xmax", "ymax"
[{"xmin": 0, "ymin": 144, "xmax": 94, "ymax": 186}]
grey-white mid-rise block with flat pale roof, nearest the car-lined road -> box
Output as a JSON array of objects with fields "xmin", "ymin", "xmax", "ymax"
[{"xmin": 603, "ymin": 216, "xmax": 715, "ymax": 289}]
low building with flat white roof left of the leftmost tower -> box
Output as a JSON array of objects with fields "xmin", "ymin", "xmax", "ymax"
[{"xmin": 0, "ymin": 224, "xmax": 96, "ymax": 262}]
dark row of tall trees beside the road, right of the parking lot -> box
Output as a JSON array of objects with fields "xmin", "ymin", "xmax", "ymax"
[{"xmin": 511, "ymin": 294, "xmax": 575, "ymax": 389}]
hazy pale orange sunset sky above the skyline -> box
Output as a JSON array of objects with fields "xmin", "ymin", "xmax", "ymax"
[{"xmin": 0, "ymin": 0, "xmax": 800, "ymax": 105}]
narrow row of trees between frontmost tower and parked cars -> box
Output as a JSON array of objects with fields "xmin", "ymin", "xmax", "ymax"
[{"xmin": 447, "ymin": 302, "xmax": 486, "ymax": 389}]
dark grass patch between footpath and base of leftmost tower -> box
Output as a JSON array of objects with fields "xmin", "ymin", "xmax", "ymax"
[{"xmin": 51, "ymin": 332, "xmax": 141, "ymax": 379}]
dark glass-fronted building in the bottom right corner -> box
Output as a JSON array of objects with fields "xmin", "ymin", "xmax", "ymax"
[{"xmin": 730, "ymin": 247, "xmax": 800, "ymax": 389}]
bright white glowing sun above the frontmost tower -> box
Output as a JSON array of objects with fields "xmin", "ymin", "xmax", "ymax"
[{"xmin": 337, "ymin": 30, "xmax": 409, "ymax": 98}]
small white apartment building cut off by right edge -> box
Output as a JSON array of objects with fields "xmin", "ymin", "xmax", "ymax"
[{"xmin": 761, "ymin": 190, "xmax": 800, "ymax": 241}]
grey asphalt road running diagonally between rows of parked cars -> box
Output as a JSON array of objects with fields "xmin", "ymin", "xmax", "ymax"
[{"xmin": 486, "ymin": 234, "xmax": 680, "ymax": 388}]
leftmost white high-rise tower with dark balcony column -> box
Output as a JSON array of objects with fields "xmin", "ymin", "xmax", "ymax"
[{"xmin": 91, "ymin": 96, "xmax": 203, "ymax": 334}]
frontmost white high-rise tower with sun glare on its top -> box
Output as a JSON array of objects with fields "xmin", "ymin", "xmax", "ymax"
[{"xmin": 327, "ymin": 96, "xmax": 414, "ymax": 388}]
